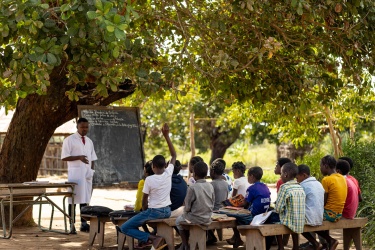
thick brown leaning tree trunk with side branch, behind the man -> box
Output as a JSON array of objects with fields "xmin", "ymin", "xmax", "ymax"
[{"xmin": 0, "ymin": 64, "xmax": 134, "ymax": 225}]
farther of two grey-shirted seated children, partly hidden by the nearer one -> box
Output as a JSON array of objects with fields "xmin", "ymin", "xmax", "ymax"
[{"xmin": 206, "ymin": 160, "xmax": 228, "ymax": 244}]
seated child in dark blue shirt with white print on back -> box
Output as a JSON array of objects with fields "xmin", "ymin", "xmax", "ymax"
[{"xmin": 227, "ymin": 166, "xmax": 271, "ymax": 248}]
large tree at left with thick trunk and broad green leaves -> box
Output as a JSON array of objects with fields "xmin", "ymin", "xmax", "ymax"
[{"xmin": 0, "ymin": 0, "xmax": 176, "ymax": 224}]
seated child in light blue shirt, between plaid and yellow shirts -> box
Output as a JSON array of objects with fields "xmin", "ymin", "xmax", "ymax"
[{"xmin": 296, "ymin": 165, "xmax": 324, "ymax": 249}]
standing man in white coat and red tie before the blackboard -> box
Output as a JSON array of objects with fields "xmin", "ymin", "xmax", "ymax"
[{"xmin": 61, "ymin": 118, "xmax": 98, "ymax": 233}]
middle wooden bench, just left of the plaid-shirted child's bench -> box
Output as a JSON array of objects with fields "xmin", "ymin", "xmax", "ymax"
[{"xmin": 180, "ymin": 217, "xmax": 237, "ymax": 250}]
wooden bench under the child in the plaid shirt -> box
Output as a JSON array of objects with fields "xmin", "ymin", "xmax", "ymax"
[{"xmin": 237, "ymin": 218, "xmax": 367, "ymax": 250}]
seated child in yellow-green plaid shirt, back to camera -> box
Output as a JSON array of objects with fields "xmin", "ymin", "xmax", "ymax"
[{"xmin": 275, "ymin": 162, "xmax": 306, "ymax": 250}]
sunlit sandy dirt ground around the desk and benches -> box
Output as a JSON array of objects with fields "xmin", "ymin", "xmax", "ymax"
[{"xmin": 0, "ymin": 177, "xmax": 364, "ymax": 250}]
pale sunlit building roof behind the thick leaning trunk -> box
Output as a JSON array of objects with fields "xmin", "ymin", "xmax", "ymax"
[{"xmin": 0, "ymin": 108, "xmax": 77, "ymax": 135}]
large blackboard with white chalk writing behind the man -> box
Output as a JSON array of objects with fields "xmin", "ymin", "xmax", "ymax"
[{"xmin": 78, "ymin": 106, "xmax": 144, "ymax": 186}]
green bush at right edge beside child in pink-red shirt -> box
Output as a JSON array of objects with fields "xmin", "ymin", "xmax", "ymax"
[{"xmin": 343, "ymin": 141, "xmax": 375, "ymax": 249}]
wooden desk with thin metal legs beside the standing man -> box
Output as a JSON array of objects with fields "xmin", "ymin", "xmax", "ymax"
[{"xmin": 0, "ymin": 182, "xmax": 77, "ymax": 239}]
